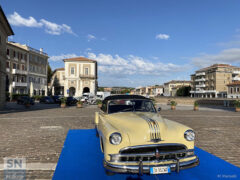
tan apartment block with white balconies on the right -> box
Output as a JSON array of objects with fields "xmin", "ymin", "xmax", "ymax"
[{"xmin": 190, "ymin": 64, "xmax": 240, "ymax": 98}]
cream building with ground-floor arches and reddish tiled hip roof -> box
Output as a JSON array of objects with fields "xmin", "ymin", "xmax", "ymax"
[{"xmin": 50, "ymin": 57, "xmax": 98, "ymax": 97}]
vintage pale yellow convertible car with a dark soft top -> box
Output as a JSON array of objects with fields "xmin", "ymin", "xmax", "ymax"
[{"xmin": 95, "ymin": 95, "xmax": 199, "ymax": 175}]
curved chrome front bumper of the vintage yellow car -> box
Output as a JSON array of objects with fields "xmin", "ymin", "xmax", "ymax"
[{"xmin": 103, "ymin": 156, "xmax": 199, "ymax": 174}]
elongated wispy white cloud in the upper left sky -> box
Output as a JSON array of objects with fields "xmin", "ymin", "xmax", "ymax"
[{"xmin": 7, "ymin": 12, "xmax": 77, "ymax": 36}]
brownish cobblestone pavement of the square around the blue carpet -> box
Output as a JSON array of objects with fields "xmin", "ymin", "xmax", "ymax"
[{"xmin": 0, "ymin": 104, "xmax": 240, "ymax": 179}]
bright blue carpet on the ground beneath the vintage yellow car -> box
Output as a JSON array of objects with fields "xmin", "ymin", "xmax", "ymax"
[{"xmin": 53, "ymin": 129, "xmax": 240, "ymax": 180}]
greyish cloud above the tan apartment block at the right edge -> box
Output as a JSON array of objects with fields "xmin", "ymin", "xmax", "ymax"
[{"xmin": 191, "ymin": 48, "xmax": 240, "ymax": 68}]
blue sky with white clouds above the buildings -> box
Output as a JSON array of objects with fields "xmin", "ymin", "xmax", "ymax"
[{"xmin": 0, "ymin": 0, "xmax": 240, "ymax": 87}]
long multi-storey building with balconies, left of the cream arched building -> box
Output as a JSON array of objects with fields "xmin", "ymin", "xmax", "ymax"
[{"xmin": 6, "ymin": 42, "xmax": 48, "ymax": 97}]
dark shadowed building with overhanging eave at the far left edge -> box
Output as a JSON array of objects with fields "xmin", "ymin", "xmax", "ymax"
[{"xmin": 0, "ymin": 6, "xmax": 14, "ymax": 108}]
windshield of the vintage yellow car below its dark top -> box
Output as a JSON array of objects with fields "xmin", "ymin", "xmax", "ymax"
[{"xmin": 108, "ymin": 99, "xmax": 156, "ymax": 114}]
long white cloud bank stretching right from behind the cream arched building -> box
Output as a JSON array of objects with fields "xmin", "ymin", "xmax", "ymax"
[{"xmin": 87, "ymin": 52, "xmax": 189, "ymax": 77}]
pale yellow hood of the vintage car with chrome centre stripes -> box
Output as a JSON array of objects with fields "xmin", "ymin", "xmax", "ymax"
[{"xmin": 107, "ymin": 112, "xmax": 171, "ymax": 144}]
